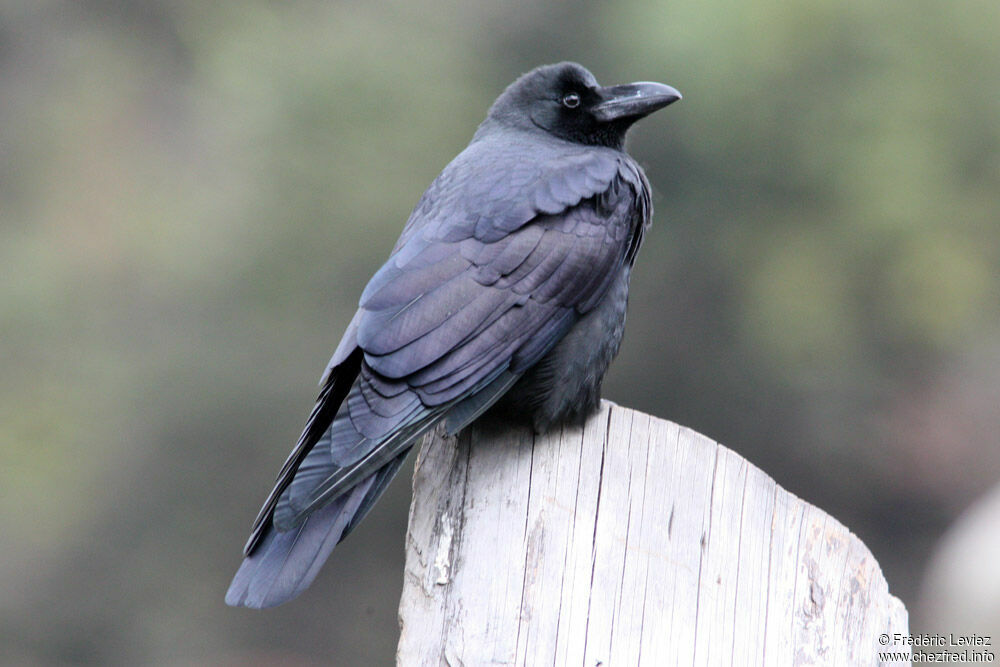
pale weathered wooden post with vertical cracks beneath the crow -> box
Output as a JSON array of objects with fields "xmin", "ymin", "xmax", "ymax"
[{"xmin": 397, "ymin": 402, "xmax": 909, "ymax": 667}]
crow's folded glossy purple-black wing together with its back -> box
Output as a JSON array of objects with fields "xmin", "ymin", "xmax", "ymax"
[{"xmin": 274, "ymin": 137, "xmax": 650, "ymax": 530}]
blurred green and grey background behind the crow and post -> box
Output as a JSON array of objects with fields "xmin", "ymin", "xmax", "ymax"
[{"xmin": 0, "ymin": 0, "xmax": 1000, "ymax": 665}]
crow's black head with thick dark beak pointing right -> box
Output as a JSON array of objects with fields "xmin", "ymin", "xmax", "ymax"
[{"xmin": 486, "ymin": 62, "xmax": 681, "ymax": 148}]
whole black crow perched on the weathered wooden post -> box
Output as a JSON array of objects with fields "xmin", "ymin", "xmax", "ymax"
[{"xmin": 226, "ymin": 62, "xmax": 681, "ymax": 608}]
